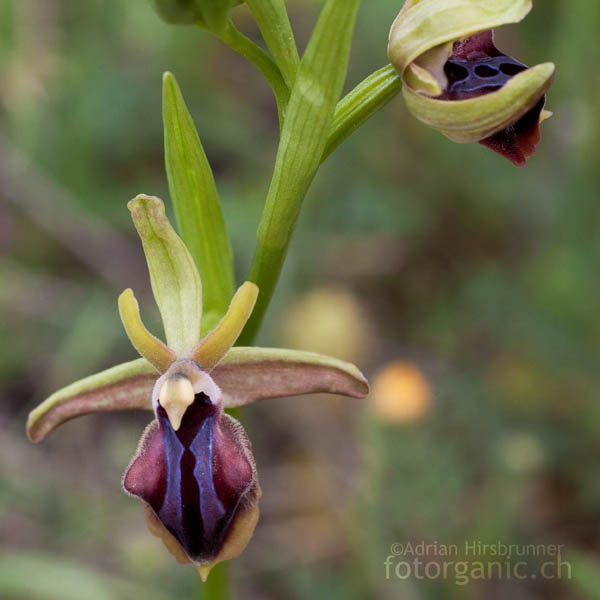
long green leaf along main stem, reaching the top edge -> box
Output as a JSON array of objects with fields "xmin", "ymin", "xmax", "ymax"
[{"xmin": 242, "ymin": 0, "xmax": 360, "ymax": 344}]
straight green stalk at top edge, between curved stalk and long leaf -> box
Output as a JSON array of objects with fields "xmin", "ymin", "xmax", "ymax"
[{"xmin": 246, "ymin": 0, "xmax": 300, "ymax": 89}]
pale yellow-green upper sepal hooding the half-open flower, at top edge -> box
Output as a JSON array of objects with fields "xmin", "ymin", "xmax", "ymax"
[{"xmin": 388, "ymin": 0, "xmax": 532, "ymax": 74}]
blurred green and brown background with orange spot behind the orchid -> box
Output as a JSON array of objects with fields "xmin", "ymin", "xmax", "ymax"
[{"xmin": 0, "ymin": 0, "xmax": 600, "ymax": 600}]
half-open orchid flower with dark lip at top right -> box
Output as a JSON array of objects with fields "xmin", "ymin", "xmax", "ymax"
[{"xmin": 388, "ymin": 0, "xmax": 554, "ymax": 166}]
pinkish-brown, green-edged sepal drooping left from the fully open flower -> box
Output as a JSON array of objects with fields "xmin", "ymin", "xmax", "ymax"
[{"xmin": 27, "ymin": 358, "xmax": 158, "ymax": 442}]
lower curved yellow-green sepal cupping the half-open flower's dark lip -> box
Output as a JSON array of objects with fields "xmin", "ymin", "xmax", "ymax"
[{"xmin": 402, "ymin": 63, "xmax": 554, "ymax": 142}]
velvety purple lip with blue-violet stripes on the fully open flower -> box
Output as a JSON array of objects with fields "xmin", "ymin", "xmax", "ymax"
[{"xmin": 124, "ymin": 393, "xmax": 253, "ymax": 563}]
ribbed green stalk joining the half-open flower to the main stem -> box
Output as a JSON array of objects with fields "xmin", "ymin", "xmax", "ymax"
[{"xmin": 323, "ymin": 65, "xmax": 402, "ymax": 160}]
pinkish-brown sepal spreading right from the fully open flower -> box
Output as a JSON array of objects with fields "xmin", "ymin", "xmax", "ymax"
[{"xmin": 211, "ymin": 347, "xmax": 369, "ymax": 408}]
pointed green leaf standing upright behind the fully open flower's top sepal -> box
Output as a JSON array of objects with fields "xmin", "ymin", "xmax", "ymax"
[{"xmin": 163, "ymin": 73, "xmax": 234, "ymax": 332}]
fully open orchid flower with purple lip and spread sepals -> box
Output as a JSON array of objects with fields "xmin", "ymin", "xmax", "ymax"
[{"xmin": 27, "ymin": 196, "xmax": 368, "ymax": 580}]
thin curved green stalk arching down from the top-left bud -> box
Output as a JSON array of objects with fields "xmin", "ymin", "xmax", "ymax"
[{"xmin": 216, "ymin": 21, "xmax": 290, "ymax": 123}]
